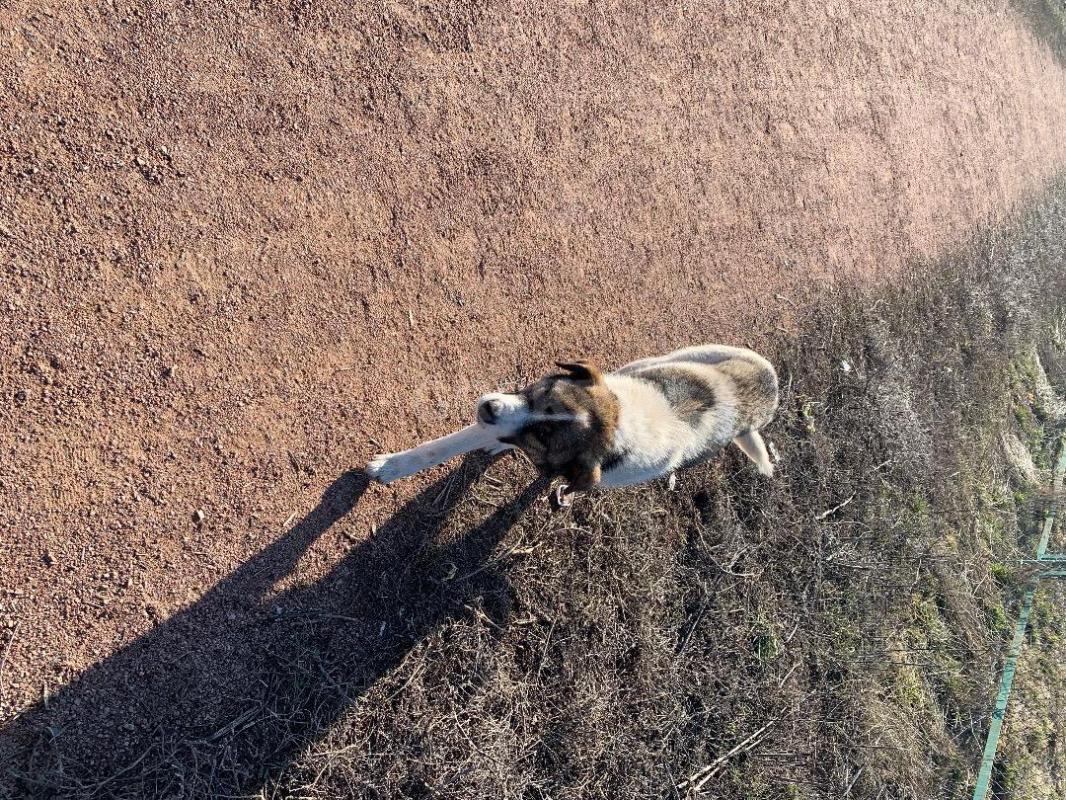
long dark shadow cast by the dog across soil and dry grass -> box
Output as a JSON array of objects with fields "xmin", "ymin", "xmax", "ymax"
[{"xmin": 0, "ymin": 457, "xmax": 547, "ymax": 798}]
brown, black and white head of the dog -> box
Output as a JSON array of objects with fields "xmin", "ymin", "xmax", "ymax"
[{"xmin": 478, "ymin": 361, "xmax": 618, "ymax": 487}]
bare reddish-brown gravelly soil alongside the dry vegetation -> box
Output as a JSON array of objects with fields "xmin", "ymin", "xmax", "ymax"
[{"xmin": 0, "ymin": 0, "xmax": 1066, "ymax": 789}]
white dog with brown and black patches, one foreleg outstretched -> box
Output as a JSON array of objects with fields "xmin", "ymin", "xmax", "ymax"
[{"xmin": 367, "ymin": 345, "xmax": 778, "ymax": 506}]
